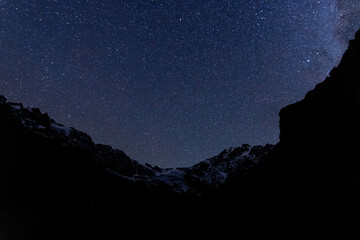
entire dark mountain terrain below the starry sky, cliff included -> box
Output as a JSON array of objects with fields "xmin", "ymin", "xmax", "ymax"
[{"xmin": 0, "ymin": 29, "xmax": 360, "ymax": 239}]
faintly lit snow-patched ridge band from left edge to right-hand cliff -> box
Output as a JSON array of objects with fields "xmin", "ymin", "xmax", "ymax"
[{"xmin": 0, "ymin": 96, "xmax": 272, "ymax": 196}]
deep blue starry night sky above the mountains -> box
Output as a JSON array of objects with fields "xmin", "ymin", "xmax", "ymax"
[{"xmin": 0, "ymin": 0, "xmax": 360, "ymax": 167}]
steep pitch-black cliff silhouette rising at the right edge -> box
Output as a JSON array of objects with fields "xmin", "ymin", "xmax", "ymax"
[{"xmin": 267, "ymin": 28, "xmax": 360, "ymax": 232}]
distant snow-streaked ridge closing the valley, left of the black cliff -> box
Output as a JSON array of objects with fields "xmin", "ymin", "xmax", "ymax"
[{"xmin": 109, "ymin": 144, "xmax": 273, "ymax": 195}]
